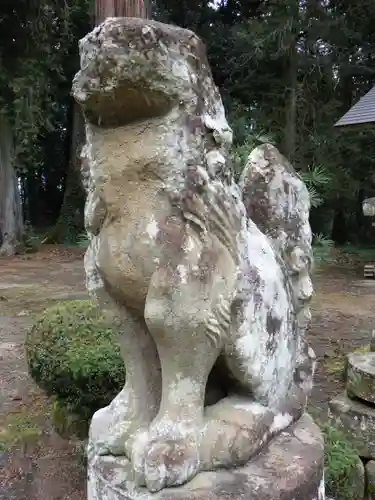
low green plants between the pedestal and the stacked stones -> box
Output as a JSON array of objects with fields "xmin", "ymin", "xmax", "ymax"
[{"xmin": 322, "ymin": 424, "xmax": 360, "ymax": 500}]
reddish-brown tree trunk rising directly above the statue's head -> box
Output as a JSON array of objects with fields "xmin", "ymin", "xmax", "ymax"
[{"xmin": 95, "ymin": 0, "xmax": 151, "ymax": 24}]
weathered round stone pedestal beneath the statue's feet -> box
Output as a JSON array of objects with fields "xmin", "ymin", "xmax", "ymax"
[{"xmin": 88, "ymin": 415, "xmax": 325, "ymax": 500}]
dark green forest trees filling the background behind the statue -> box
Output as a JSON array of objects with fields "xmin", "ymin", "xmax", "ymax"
[{"xmin": 0, "ymin": 0, "xmax": 375, "ymax": 243}]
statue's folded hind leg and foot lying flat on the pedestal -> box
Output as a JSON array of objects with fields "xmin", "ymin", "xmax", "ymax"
[{"xmin": 201, "ymin": 334, "xmax": 315, "ymax": 470}]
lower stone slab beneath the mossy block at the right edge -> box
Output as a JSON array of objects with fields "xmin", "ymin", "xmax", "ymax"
[{"xmin": 329, "ymin": 393, "xmax": 375, "ymax": 458}]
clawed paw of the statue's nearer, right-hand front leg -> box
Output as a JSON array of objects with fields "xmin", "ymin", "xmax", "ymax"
[{"xmin": 144, "ymin": 438, "xmax": 200, "ymax": 492}]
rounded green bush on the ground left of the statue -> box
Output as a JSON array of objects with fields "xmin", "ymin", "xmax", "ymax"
[{"xmin": 26, "ymin": 300, "xmax": 125, "ymax": 419}]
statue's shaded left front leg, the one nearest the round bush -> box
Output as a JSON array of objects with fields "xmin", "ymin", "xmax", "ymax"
[{"xmin": 90, "ymin": 301, "xmax": 161, "ymax": 455}]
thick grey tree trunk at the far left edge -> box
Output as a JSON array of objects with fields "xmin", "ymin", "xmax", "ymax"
[{"xmin": 0, "ymin": 118, "xmax": 23, "ymax": 256}]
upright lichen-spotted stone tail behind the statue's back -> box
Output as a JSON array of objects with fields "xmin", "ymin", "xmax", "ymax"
[{"xmin": 240, "ymin": 144, "xmax": 313, "ymax": 384}]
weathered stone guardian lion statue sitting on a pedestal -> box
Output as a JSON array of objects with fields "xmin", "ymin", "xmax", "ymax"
[{"xmin": 73, "ymin": 18, "xmax": 324, "ymax": 498}]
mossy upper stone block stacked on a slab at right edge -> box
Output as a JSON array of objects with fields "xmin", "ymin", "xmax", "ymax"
[{"xmin": 346, "ymin": 352, "xmax": 375, "ymax": 403}]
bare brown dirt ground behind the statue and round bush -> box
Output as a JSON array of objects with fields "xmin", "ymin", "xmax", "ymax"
[{"xmin": 0, "ymin": 247, "xmax": 375, "ymax": 500}]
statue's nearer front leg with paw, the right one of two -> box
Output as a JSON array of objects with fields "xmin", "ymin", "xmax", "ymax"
[{"xmin": 132, "ymin": 256, "xmax": 229, "ymax": 491}]
